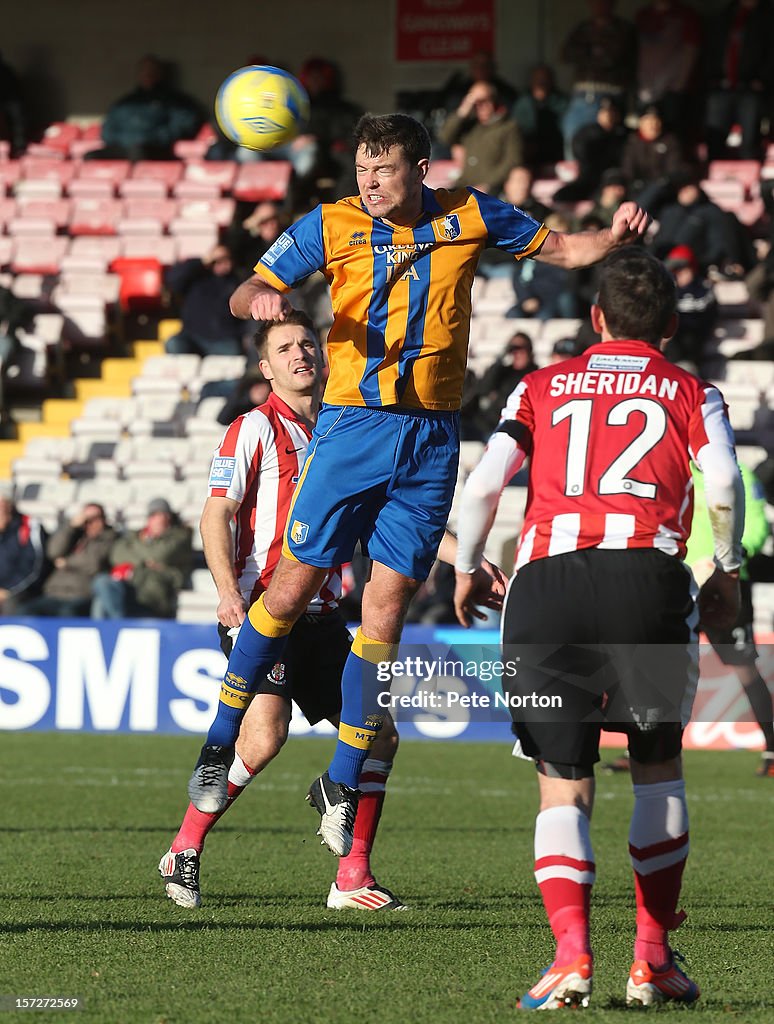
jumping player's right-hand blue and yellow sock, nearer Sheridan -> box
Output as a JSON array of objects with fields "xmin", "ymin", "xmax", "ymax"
[{"xmin": 328, "ymin": 629, "xmax": 397, "ymax": 790}]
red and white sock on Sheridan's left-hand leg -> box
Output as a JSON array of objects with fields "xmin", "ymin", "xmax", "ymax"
[{"xmin": 534, "ymin": 806, "xmax": 596, "ymax": 965}]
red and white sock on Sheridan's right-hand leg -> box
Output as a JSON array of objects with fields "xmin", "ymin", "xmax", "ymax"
[{"xmin": 629, "ymin": 779, "xmax": 688, "ymax": 968}]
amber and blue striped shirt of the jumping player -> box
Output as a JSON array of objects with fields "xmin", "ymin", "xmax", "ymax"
[{"xmin": 255, "ymin": 186, "xmax": 548, "ymax": 411}]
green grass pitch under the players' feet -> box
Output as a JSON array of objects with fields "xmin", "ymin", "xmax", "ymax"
[{"xmin": 0, "ymin": 733, "xmax": 774, "ymax": 1024}]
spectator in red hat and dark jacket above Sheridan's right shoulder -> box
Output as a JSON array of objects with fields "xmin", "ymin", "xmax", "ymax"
[{"xmin": 664, "ymin": 246, "xmax": 718, "ymax": 374}]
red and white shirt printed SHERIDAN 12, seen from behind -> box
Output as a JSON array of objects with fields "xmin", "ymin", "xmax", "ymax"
[{"xmin": 458, "ymin": 341, "xmax": 733, "ymax": 570}]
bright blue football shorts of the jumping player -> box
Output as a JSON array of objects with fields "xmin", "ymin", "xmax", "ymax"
[{"xmin": 283, "ymin": 406, "xmax": 460, "ymax": 580}]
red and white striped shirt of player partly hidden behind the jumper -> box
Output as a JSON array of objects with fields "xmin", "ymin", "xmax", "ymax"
[{"xmin": 209, "ymin": 393, "xmax": 341, "ymax": 613}]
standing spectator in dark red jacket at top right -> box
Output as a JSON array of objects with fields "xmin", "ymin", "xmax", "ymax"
[{"xmin": 635, "ymin": 0, "xmax": 701, "ymax": 141}]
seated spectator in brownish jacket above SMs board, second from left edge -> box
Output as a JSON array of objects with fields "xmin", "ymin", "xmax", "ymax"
[{"xmin": 13, "ymin": 503, "xmax": 116, "ymax": 616}]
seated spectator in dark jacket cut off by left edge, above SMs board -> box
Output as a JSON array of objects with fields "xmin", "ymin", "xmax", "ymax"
[{"xmin": 0, "ymin": 484, "xmax": 46, "ymax": 615}]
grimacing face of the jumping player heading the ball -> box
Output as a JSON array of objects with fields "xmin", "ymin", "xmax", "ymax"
[{"xmin": 355, "ymin": 145, "xmax": 429, "ymax": 224}]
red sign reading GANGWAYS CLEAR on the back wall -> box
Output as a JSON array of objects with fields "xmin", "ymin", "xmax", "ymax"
[{"xmin": 395, "ymin": 0, "xmax": 495, "ymax": 60}]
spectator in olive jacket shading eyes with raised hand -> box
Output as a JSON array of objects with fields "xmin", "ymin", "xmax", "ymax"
[{"xmin": 440, "ymin": 82, "xmax": 523, "ymax": 196}]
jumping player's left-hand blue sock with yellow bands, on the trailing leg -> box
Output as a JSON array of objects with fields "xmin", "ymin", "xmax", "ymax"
[{"xmin": 207, "ymin": 594, "xmax": 294, "ymax": 746}]
